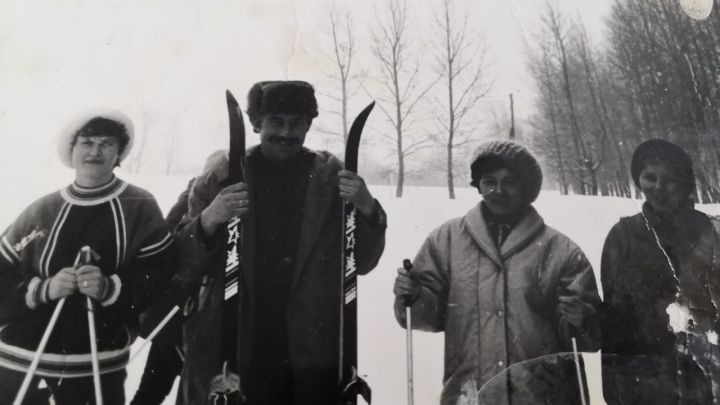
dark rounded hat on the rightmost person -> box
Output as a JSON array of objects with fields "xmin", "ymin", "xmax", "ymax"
[{"xmin": 630, "ymin": 139, "xmax": 695, "ymax": 194}]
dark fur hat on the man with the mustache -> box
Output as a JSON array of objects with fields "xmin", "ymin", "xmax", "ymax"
[{"xmin": 247, "ymin": 80, "xmax": 318, "ymax": 125}]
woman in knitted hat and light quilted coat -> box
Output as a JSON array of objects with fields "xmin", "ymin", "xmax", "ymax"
[{"xmin": 394, "ymin": 141, "xmax": 600, "ymax": 405}]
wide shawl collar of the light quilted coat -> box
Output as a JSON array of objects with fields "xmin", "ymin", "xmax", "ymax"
[{"xmin": 465, "ymin": 203, "xmax": 545, "ymax": 268}]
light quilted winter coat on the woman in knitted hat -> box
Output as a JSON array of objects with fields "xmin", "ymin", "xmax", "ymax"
[{"xmin": 395, "ymin": 204, "xmax": 600, "ymax": 405}]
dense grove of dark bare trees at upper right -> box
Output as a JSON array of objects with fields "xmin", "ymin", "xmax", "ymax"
[{"xmin": 528, "ymin": 0, "xmax": 720, "ymax": 203}]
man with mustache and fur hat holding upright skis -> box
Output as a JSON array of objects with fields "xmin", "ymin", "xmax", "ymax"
[{"xmin": 178, "ymin": 81, "xmax": 386, "ymax": 405}]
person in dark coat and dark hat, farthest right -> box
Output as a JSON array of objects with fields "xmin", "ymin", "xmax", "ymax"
[{"xmin": 601, "ymin": 139, "xmax": 720, "ymax": 405}]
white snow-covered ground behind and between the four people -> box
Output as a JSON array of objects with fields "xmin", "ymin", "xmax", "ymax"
[{"xmin": 0, "ymin": 173, "xmax": 720, "ymax": 405}]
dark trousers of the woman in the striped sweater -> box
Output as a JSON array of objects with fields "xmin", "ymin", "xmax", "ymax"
[{"xmin": 0, "ymin": 368, "xmax": 127, "ymax": 405}]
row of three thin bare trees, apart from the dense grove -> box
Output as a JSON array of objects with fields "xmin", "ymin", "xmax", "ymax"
[{"xmin": 321, "ymin": 0, "xmax": 491, "ymax": 198}]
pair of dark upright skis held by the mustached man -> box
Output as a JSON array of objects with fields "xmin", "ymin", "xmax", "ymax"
[{"xmin": 211, "ymin": 91, "xmax": 375, "ymax": 405}]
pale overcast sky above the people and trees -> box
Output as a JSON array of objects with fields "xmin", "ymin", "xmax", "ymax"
[{"xmin": 0, "ymin": 0, "xmax": 610, "ymax": 186}]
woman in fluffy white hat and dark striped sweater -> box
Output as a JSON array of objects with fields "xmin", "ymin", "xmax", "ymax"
[{"xmin": 0, "ymin": 111, "xmax": 173, "ymax": 405}]
